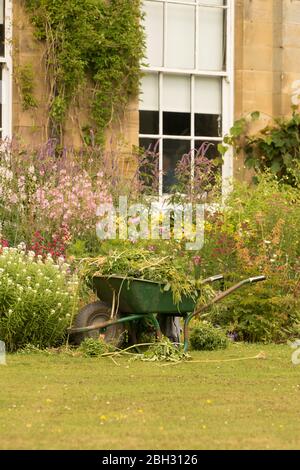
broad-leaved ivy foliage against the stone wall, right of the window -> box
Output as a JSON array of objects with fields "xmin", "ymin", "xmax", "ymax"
[{"xmin": 219, "ymin": 106, "xmax": 300, "ymax": 187}]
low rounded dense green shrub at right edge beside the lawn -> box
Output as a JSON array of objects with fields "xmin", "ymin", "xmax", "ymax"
[{"xmin": 215, "ymin": 273, "xmax": 300, "ymax": 342}]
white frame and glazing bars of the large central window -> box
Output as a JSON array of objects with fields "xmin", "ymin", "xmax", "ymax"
[{"xmin": 139, "ymin": 0, "xmax": 235, "ymax": 197}]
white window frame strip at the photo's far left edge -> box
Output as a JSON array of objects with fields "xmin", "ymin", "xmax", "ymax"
[{"xmin": 0, "ymin": 0, "xmax": 13, "ymax": 140}]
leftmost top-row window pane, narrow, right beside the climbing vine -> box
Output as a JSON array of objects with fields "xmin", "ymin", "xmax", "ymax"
[{"xmin": 144, "ymin": 1, "xmax": 164, "ymax": 67}]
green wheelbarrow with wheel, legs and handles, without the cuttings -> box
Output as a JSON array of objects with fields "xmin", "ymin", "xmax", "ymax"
[{"xmin": 68, "ymin": 274, "xmax": 266, "ymax": 351}]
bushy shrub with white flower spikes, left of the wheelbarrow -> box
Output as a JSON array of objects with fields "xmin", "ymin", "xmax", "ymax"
[{"xmin": 0, "ymin": 247, "xmax": 78, "ymax": 351}]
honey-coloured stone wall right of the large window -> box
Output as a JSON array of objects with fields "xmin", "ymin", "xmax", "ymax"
[{"xmin": 234, "ymin": 0, "xmax": 300, "ymax": 178}]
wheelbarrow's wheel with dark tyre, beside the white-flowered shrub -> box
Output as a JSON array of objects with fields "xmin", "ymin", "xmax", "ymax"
[{"xmin": 72, "ymin": 301, "xmax": 125, "ymax": 347}]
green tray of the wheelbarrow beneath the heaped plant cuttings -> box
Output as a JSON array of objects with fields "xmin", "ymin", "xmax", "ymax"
[{"xmin": 92, "ymin": 276, "xmax": 196, "ymax": 316}]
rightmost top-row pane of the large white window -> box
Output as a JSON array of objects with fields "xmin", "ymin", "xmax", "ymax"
[{"xmin": 198, "ymin": 7, "xmax": 225, "ymax": 70}]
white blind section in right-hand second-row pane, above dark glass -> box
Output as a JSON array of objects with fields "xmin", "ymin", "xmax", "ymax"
[{"xmin": 195, "ymin": 77, "xmax": 222, "ymax": 114}]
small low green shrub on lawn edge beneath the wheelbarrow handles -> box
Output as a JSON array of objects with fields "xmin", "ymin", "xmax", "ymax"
[{"xmin": 190, "ymin": 322, "xmax": 228, "ymax": 351}]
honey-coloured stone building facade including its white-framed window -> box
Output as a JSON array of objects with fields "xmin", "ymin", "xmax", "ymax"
[{"xmin": 0, "ymin": 0, "xmax": 300, "ymax": 191}]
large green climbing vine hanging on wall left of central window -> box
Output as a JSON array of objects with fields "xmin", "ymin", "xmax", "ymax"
[{"xmin": 24, "ymin": 0, "xmax": 145, "ymax": 143}]
